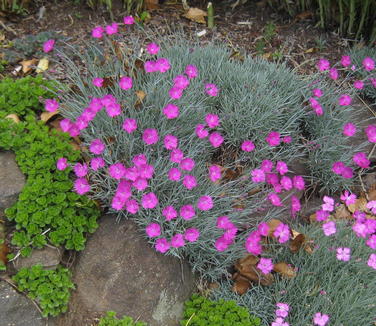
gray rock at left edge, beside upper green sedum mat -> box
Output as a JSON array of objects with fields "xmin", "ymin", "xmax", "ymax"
[{"xmin": 0, "ymin": 152, "xmax": 25, "ymax": 217}]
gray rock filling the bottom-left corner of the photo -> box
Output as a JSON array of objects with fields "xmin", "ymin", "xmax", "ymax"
[{"xmin": 0, "ymin": 281, "xmax": 46, "ymax": 326}]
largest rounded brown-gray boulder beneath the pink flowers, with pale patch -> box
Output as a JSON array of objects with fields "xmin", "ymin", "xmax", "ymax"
[{"xmin": 58, "ymin": 216, "xmax": 195, "ymax": 326}]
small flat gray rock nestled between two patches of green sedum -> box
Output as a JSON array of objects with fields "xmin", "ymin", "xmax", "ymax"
[{"xmin": 13, "ymin": 246, "xmax": 63, "ymax": 270}]
